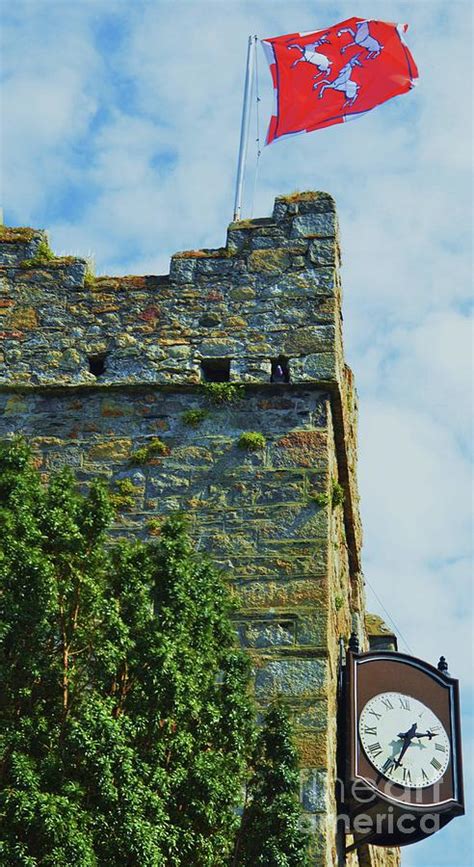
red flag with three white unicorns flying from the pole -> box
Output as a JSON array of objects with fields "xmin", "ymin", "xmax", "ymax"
[{"xmin": 262, "ymin": 18, "xmax": 418, "ymax": 144}]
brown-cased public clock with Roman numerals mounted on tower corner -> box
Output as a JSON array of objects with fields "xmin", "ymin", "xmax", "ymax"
[{"xmin": 343, "ymin": 651, "xmax": 464, "ymax": 846}]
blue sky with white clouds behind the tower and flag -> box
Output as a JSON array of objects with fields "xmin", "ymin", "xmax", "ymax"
[{"xmin": 0, "ymin": 0, "xmax": 474, "ymax": 867}]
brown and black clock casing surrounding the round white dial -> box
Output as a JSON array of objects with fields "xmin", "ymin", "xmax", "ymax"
[{"xmin": 340, "ymin": 650, "xmax": 464, "ymax": 848}]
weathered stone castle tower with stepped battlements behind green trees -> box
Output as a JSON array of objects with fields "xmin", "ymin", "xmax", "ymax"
[{"xmin": 0, "ymin": 193, "xmax": 398, "ymax": 867}]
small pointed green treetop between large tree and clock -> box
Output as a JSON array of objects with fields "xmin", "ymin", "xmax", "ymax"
[{"xmin": 233, "ymin": 707, "xmax": 309, "ymax": 867}]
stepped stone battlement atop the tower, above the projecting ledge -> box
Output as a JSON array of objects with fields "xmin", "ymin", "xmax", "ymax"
[{"xmin": 0, "ymin": 193, "xmax": 342, "ymax": 387}]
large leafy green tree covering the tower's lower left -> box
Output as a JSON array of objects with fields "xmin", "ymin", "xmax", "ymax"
[{"xmin": 0, "ymin": 440, "xmax": 253, "ymax": 867}]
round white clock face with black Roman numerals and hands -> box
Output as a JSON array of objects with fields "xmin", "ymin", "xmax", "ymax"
[{"xmin": 359, "ymin": 692, "xmax": 450, "ymax": 789}]
